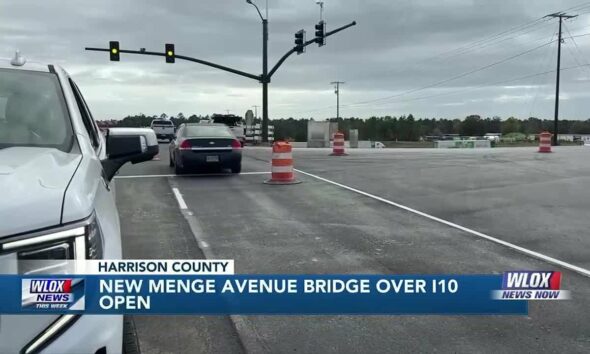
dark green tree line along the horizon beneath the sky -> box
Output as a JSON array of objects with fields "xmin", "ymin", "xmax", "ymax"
[{"xmin": 99, "ymin": 113, "xmax": 590, "ymax": 141}]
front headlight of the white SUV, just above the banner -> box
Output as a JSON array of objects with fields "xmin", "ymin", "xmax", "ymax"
[{"xmin": 0, "ymin": 215, "xmax": 103, "ymax": 274}]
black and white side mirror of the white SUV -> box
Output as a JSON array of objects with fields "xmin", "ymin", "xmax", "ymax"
[{"xmin": 102, "ymin": 128, "xmax": 159, "ymax": 181}]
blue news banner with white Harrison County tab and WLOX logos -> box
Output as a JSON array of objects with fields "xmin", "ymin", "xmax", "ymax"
[{"xmin": 0, "ymin": 260, "xmax": 570, "ymax": 315}]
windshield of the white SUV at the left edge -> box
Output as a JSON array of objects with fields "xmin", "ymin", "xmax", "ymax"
[{"xmin": 0, "ymin": 70, "xmax": 73, "ymax": 151}]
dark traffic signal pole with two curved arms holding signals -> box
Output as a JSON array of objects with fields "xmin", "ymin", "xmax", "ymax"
[{"xmin": 85, "ymin": 20, "xmax": 356, "ymax": 142}]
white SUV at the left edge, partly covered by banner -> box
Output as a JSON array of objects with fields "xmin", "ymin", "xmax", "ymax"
[{"xmin": 0, "ymin": 53, "xmax": 158, "ymax": 353}]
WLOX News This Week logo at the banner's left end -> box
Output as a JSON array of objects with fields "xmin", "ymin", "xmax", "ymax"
[{"xmin": 21, "ymin": 278, "xmax": 85, "ymax": 310}]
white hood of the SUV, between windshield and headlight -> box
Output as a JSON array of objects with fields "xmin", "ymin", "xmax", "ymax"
[{"xmin": 0, "ymin": 147, "xmax": 82, "ymax": 237}]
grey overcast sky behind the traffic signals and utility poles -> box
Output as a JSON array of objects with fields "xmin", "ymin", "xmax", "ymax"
[{"xmin": 0, "ymin": 0, "xmax": 590, "ymax": 119}]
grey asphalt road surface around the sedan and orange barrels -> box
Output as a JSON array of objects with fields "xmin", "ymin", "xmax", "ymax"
[{"xmin": 116, "ymin": 145, "xmax": 590, "ymax": 353}]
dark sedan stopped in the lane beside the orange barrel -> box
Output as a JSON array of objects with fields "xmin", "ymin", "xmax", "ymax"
[{"xmin": 170, "ymin": 123, "xmax": 242, "ymax": 174}]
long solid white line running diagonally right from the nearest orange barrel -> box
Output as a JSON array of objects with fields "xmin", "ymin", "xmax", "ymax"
[{"xmin": 295, "ymin": 169, "xmax": 590, "ymax": 277}]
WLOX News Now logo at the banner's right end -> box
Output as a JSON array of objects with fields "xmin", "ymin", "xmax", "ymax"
[{"xmin": 492, "ymin": 271, "xmax": 570, "ymax": 300}]
